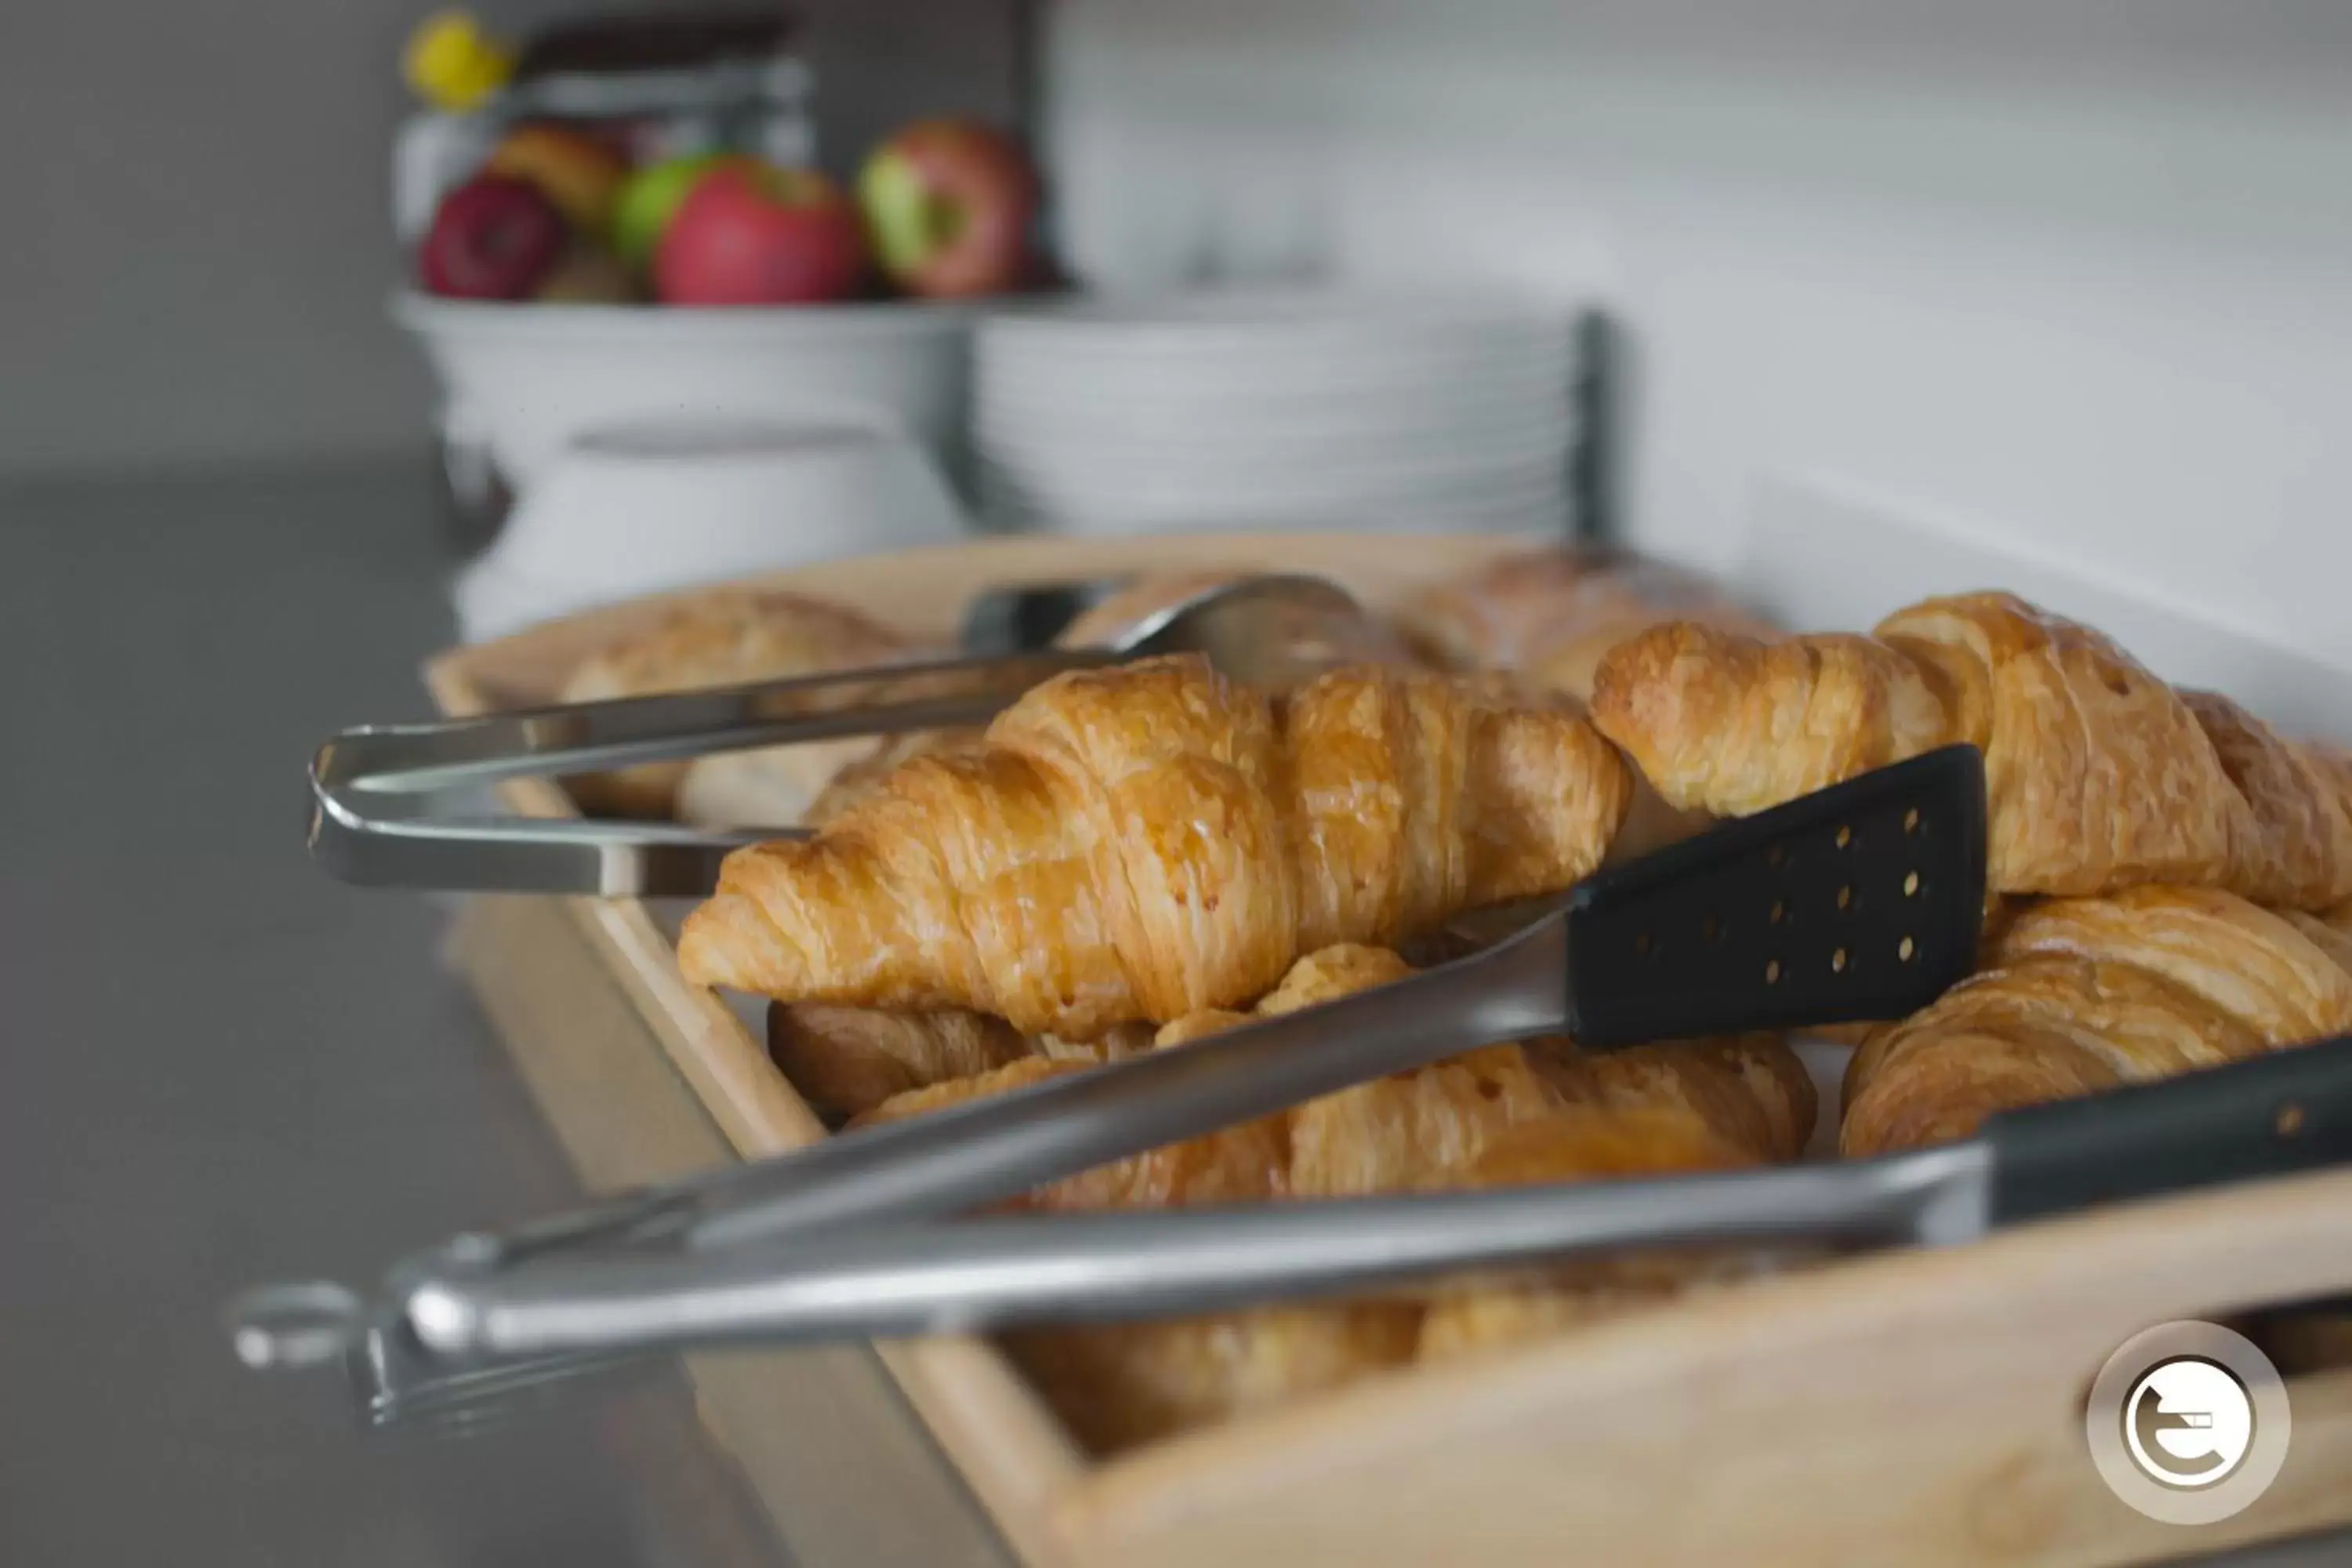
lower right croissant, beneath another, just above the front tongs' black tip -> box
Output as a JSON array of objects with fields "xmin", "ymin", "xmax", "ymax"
[{"xmin": 1839, "ymin": 886, "xmax": 2352, "ymax": 1154}]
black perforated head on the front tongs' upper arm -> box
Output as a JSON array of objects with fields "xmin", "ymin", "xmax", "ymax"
[{"xmin": 1569, "ymin": 746, "xmax": 1985, "ymax": 1048}]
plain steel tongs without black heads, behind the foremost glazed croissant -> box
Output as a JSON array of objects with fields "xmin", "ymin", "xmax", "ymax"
[{"xmin": 308, "ymin": 576, "xmax": 1364, "ymax": 898}]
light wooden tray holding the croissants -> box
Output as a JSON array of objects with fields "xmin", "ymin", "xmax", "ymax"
[{"xmin": 426, "ymin": 536, "xmax": 2352, "ymax": 1568}]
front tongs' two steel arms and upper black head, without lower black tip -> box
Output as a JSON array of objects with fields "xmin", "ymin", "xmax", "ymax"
[{"xmin": 238, "ymin": 748, "xmax": 2013, "ymax": 1415}]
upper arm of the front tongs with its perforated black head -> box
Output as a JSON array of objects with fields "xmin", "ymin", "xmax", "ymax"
[{"xmin": 247, "ymin": 748, "xmax": 1985, "ymax": 1359}]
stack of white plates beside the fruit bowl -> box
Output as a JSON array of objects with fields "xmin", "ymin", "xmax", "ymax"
[{"xmin": 974, "ymin": 292, "xmax": 1576, "ymax": 534}]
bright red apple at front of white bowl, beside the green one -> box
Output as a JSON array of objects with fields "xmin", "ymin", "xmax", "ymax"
[{"xmin": 654, "ymin": 162, "xmax": 866, "ymax": 306}]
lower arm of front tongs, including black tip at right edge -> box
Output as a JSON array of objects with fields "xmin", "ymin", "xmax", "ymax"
[{"xmin": 248, "ymin": 1036, "xmax": 2352, "ymax": 1368}]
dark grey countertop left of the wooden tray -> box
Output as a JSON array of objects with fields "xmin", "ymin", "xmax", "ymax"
[{"xmin": 0, "ymin": 461, "xmax": 2352, "ymax": 1568}]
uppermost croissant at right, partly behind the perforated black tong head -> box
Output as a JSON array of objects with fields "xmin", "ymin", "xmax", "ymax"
[{"xmin": 1592, "ymin": 593, "xmax": 2352, "ymax": 907}]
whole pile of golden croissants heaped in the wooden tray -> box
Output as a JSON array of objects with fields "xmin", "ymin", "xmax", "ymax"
[{"xmin": 541, "ymin": 553, "xmax": 2352, "ymax": 1448}]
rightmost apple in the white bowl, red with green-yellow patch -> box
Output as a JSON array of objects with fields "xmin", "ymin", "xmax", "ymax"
[{"xmin": 858, "ymin": 120, "xmax": 1037, "ymax": 299}]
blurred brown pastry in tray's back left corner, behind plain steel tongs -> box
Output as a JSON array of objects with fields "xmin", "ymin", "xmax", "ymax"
[{"xmin": 560, "ymin": 588, "xmax": 913, "ymax": 825}]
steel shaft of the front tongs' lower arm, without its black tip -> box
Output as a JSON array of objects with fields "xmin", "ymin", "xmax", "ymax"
[{"xmin": 405, "ymin": 1145, "xmax": 1987, "ymax": 1361}]
